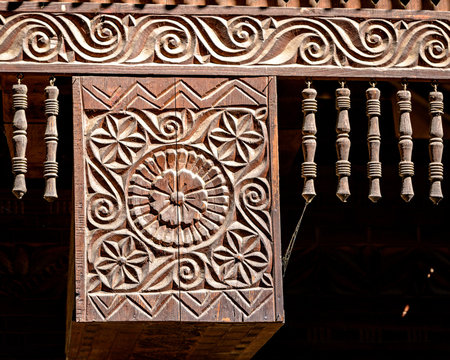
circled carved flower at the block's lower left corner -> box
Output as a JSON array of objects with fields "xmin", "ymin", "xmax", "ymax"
[{"xmin": 93, "ymin": 233, "xmax": 151, "ymax": 290}]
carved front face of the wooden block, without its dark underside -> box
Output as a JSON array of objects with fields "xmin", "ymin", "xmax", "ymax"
[{"xmin": 81, "ymin": 78, "xmax": 274, "ymax": 319}]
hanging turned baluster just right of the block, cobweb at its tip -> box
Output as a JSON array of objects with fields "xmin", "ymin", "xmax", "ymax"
[{"xmin": 302, "ymin": 81, "xmax": 317, "ymax": 203}]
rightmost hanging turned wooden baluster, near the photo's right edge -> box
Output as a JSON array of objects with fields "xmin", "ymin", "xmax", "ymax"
[{"xmin": 428, "ymin": 84, "xmax": 444, "ymax": 204}]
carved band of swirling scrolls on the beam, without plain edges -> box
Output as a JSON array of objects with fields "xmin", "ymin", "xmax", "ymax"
[{"xmin": 0, "ymin": 13, "xmax": 450, "ymax": 68}]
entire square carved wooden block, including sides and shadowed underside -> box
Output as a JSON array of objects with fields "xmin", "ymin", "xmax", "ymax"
[{"xmin": 67, "ymin": 77, "xmax": 284, "ymax": 359}]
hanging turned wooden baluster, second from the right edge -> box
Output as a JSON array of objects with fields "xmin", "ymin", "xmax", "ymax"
[{"xmin": 397, "ymin": 83, "xmax": 414, "ymax": 202}]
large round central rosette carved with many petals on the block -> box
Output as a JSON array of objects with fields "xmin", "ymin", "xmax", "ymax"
[{"xmin": 128, "ymin": 148, "xmax": 230, "ymax": 250}]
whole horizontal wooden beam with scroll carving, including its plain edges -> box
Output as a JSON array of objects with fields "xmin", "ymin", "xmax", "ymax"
[{"xmin": 0, "ymin": 4, "xmax": 450, "ymax": 80}]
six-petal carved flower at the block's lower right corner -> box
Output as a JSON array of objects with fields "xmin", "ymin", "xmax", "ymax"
[{"xmin": 213, "ymin": 224, "xmax": 269, "ymax": 287}]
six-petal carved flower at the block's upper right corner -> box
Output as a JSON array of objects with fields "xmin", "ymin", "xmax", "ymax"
[{"xmin": 210, "ymin": 111, "xmax": 263, "ymax": 166}]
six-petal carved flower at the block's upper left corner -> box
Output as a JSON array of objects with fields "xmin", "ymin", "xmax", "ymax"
[{"xmin": 91, "ymin": 113, "xmax": 146, "ymax": 170}]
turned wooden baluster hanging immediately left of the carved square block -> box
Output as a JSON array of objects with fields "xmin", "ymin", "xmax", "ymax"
[{"xmin": 44, "ymin": 78, "xmax": 59, "ymax": 202}]
